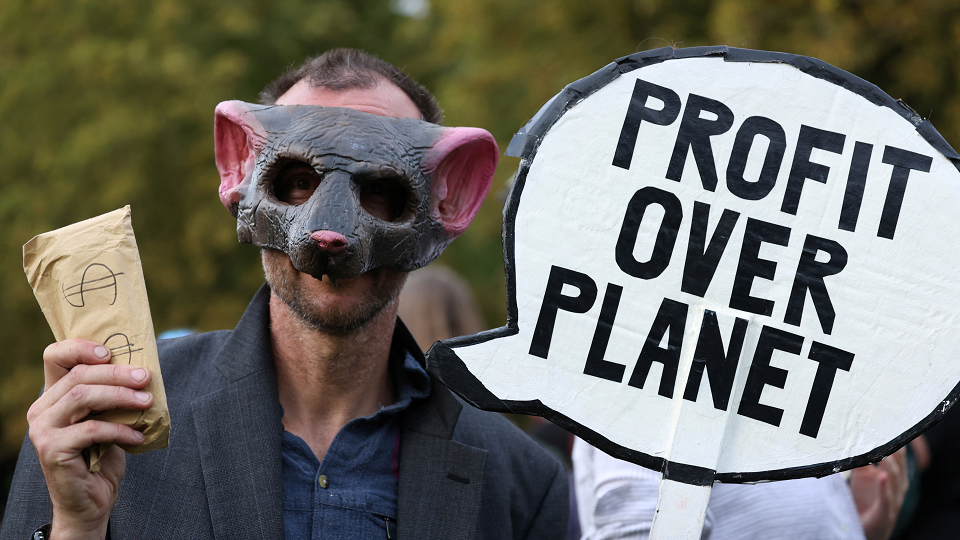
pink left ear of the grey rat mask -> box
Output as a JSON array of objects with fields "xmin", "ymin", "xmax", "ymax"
[{"xmin": 213, "ymin": 101, "xmax": 266, "ymax": 212}]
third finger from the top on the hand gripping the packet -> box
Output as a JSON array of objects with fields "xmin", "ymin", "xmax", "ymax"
[{"xmin": 42, "ymin": 384, "xmax": 153, "ymax": 428}]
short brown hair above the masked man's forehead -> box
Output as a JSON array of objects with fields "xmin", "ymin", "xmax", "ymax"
[{"xmin": 260, "ymin": 49, "xmax": 443, "ymax": 124}]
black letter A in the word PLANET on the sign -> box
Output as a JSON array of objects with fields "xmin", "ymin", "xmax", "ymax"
[{"xmin": 627, "ymin": 298, "xmax": 687, "ymax": 398}]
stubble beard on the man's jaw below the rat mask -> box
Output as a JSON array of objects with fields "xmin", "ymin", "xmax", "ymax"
[{"xmin": 261, "ymin": 249, "xmax": 406, "ymax": 336}]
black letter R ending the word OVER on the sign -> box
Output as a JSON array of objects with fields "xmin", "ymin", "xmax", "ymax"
[{"xmin": 783, "ymin": 234, "xmax": 847, "ymax": 334}]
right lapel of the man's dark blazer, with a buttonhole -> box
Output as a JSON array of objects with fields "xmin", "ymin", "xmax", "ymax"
[{"xmin": 394, "ymin": 320, "xmax": 487, "ymax": 540}]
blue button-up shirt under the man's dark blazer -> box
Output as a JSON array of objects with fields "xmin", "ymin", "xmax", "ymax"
[{"xmin": 282, "ymin": 349, "xmax": 430, "ymax": 540}]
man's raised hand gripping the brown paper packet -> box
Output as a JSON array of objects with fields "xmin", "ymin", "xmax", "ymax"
[{"xmin": 27, "ymin": 339, "xmax": 153, "ymax": 540}]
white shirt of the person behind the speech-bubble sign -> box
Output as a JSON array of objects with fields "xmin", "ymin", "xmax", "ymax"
[{"xmin": 573, "ymin": 439, "xmax": 864, "ymax": 540}]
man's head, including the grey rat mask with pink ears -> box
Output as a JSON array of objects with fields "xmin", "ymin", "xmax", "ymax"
[{"xmin": 216, "ymin": 51, "xmax": 498, "ymax": 331}]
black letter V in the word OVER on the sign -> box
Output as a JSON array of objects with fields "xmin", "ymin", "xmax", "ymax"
[{"xmin": 680, "ymin": 201, "xmax": 740, "ymax": 298}]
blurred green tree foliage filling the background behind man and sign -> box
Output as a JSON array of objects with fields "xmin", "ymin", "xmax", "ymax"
[{"xmin": 0, "ymin": 0, "xmax": 960, "ymax": 498}]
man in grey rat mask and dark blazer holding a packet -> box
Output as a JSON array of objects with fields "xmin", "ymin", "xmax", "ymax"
[{"xmin": 0, "ymin": 50, "xmax": 567, "ymax": 539}]
